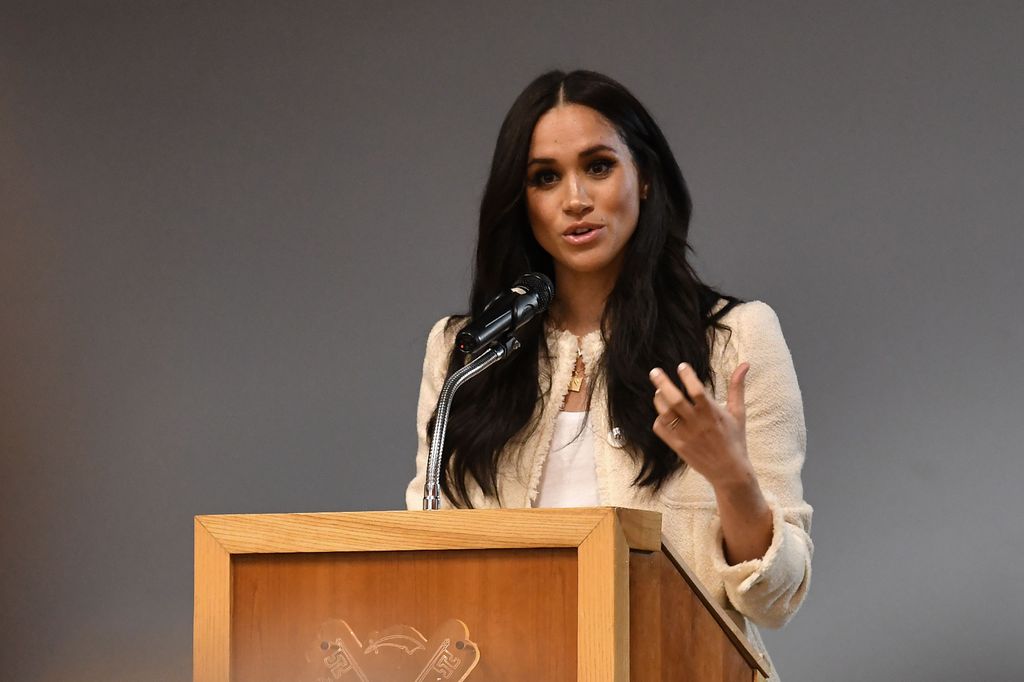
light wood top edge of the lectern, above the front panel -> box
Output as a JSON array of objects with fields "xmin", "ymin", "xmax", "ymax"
[{"xmin": 196, "ymin": 507, "xmax": 662, "ymax": 554}]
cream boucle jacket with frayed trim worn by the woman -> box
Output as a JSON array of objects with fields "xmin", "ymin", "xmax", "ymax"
[{"xmin": 406, "ymin": 301, "xmax": 813, "ymax": 681}]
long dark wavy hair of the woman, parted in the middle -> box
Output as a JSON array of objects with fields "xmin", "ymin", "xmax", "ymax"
[{"xmin": 428, "ymin": 71, "xmax": 738, "ymax": 506}]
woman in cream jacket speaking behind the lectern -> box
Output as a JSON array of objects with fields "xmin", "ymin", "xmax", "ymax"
[{"xmin": 407, "ymin": 71, "xmax": 813, "ymax": 675}]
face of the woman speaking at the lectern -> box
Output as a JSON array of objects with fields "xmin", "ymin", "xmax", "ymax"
[{"xmin": 526, "ymin": 104, "xmax": 640, "ymax": 279}]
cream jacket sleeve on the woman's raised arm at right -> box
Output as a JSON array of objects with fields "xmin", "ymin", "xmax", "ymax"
[{"xmin": 707, "ymin": 302, "xmax": 814, "ymax": 628}]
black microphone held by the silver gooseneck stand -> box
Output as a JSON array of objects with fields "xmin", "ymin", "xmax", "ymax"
[{"xmin": 455, "ymin": 272, "xmax": 555, "ymax": 353}]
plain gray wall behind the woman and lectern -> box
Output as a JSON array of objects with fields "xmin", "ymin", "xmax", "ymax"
[{"xmin": 0, "ymin": 0, "xmax": 1024, "ymax": 682}]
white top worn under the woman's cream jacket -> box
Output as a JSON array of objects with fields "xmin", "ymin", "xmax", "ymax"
[{"xmin": 534, "ymin": 412, "xmax": 601, "ymax": 507}]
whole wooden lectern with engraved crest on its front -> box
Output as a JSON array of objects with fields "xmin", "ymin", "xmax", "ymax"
[{"xmin": 194, "ymin": 507, "xmax": 767, "ymax": 682}]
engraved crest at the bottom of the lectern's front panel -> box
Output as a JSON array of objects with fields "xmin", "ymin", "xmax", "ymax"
[{"xmin": 306, "ymin": 619, "xmax": 480, "ymax": 682}]
